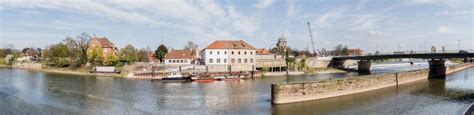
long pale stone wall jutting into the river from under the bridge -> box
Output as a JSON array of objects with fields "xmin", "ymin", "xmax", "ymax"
[{"xmin": 272, "ymin": 63, "xmax": 474, "ymax": 104}]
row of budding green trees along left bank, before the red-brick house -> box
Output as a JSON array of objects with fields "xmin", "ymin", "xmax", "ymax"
[{"xmin": 42, "ymin": 33, "xmax": 150, "ymax": 68}]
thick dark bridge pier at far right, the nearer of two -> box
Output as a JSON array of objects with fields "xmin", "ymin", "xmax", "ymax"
[{"xmin": 428, "ymin": 59, "xmax": 446, "ymax": 79}]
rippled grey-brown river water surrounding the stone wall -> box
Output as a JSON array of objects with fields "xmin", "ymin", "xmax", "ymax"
[{"xmin": 0, "ymin": 64, "xmax": 474, "ymax": 115}]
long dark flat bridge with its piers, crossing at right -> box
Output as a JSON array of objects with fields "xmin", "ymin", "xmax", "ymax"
[{"xmin": 329, "ymin": 53, "xmax": 474, "ymax": 79}]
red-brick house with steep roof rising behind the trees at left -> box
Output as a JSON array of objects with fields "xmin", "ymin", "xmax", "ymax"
[{"xmin": 88, "ymin": 34, "xmax": 118, "ymax": 57}]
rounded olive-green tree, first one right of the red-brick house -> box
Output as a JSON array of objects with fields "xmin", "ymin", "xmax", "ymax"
[{"xmin": 119, "ymin": 44, "xmax": 138, "ymax": 64}]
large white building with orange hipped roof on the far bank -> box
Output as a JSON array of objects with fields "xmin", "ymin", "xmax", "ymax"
[{"xmin": 201, "ymin": 40, "xmax": 256, "ymax": 67}]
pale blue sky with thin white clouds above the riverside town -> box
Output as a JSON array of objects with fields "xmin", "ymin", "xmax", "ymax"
[{"xmin": 0, "ymin": 0, "xmax": 474, "ymax": 52}]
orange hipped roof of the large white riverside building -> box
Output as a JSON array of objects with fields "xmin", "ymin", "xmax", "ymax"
[{"xmin": 206, "ymin": 40, "xmax": 255, "ymax": 50}]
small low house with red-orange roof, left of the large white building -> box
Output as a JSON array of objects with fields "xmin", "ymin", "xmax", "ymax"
[{"xmin": 164, "ymin": 49, "xmax": 194, "ymax": 65}]
